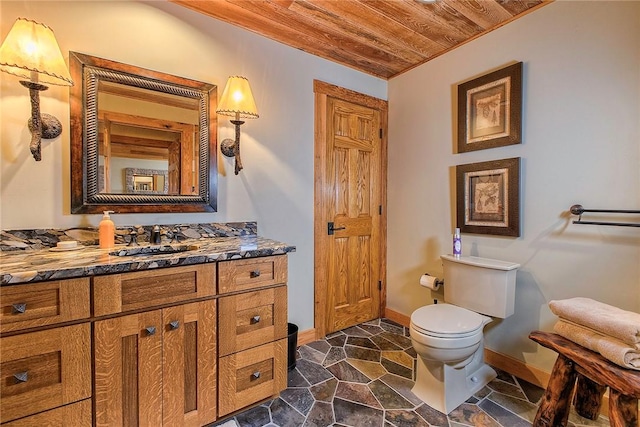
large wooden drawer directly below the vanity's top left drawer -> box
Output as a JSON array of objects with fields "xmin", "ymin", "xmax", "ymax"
[{"xmin": 0, "ymin": 323, "xmax": 91, "ymax": 422}]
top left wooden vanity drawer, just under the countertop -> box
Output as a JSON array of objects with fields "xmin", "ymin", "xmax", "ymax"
[{"xmin": 0, "ymin": 278, "xmax": 90, "ymax": 333}]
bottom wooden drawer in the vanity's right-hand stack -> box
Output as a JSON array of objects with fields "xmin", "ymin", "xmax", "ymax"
[{"xmin": 218, "ymin": 338, "xmax": 287, "ymax": 417}]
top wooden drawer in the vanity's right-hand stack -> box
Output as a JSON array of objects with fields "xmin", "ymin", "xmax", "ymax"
[{"xmin": 218, "ymin": 255, "xmax": 287, "ymax": 294}]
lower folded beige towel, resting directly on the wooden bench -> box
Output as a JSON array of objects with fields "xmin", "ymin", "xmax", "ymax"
[{"xmin": 553, "ymin": 319, "xmax": 640, "ymax": 371}]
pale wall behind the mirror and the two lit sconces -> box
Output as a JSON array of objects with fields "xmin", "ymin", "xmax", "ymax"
[{"xmin": 0, "ymin": 0, "xmax": 387, "ymax": 330}]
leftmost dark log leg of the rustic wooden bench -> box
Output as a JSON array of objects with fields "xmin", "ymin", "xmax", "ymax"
[{"xmin": 533, "ymin": 354, "xmax": 577, "ymax": 427}]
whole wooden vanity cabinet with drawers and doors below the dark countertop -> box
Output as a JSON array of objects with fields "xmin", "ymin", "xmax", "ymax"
[{"xmin": 0, "ymin": 255, "xmax": 287, "ymax": 427}]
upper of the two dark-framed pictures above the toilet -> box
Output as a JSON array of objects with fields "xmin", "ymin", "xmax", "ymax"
[{"xmin": 458, "ymin": 62, "xmax": 522, "ymax": 153}]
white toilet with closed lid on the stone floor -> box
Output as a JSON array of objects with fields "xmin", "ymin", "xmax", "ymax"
[{"xmin": 410, "ymin": 255, "xmax": 520, "ymax": 414}]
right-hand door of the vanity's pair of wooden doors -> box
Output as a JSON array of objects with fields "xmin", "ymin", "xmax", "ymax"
[{"xmin": 163, "ymin": 300, "xmax": 217, "ymax": 426}]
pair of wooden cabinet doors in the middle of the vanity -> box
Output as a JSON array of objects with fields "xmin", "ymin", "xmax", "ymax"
[{"xmin": 95, "ymin": 300, "xmax": 217, "ymax": 427}]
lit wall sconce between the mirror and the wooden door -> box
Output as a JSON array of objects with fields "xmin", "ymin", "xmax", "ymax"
[{"xmin": 216, "ymin": 76, "xmax": 259, "ymax": 175}]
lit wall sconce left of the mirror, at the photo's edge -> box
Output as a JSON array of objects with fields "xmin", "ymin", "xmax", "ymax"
[{"xmin": 0, "ymin": 18, "xmax": 73, "ymax": 161}]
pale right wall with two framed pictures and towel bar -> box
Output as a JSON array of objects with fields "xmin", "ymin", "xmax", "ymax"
[{"xmin": 388, "ymin": 1, "xmax": 640, "ymax": 371}]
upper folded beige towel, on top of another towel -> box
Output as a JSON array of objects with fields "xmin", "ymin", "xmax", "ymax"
[{"xmin": 549, "ymin": 297, "xmax": 640, "ymax": 345}]
